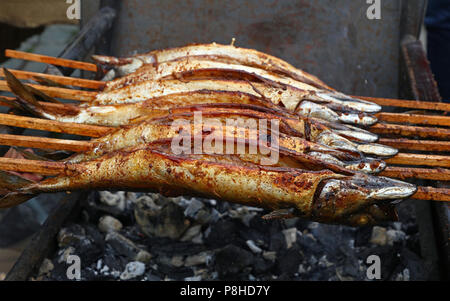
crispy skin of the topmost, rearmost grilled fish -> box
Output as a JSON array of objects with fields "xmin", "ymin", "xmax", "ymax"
[{"xmin": 93, "ymin": 43, "xmax": 333, "ymax": 90}]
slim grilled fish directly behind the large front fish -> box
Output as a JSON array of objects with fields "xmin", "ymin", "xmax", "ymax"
[{"xmin": 67, "ymin": 114, "xmax": 386, "ymax": 173}]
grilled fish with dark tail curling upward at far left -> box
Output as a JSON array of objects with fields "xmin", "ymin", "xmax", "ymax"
[{"xmin": 14, "ymin": 86, "xmax": 397, "ymax": 157}]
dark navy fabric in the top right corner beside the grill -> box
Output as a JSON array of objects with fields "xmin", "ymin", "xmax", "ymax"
[{"xmin": 425, "ymin": 0, "xmax": 450, "ymax": 102}]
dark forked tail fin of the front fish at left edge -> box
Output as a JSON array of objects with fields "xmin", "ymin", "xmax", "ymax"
[{"xmin": 0, "ymin": 170, "xmax": 35, "ymax": 208}]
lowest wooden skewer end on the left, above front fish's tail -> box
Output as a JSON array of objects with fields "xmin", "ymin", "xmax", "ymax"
[{"xmin": 0, "ymin": 158, "xmax": 65, "ymax": 176}]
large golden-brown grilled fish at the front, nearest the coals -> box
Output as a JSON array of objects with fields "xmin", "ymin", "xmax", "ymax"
[{"xmin": 0, "ymin": 146, "xmax": 415, "ymax": 225}]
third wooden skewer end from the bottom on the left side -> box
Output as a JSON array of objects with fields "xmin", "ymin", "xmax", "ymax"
[{"xmin": 0, "ymin": 113, "xmax": 111, "ymax": 137}]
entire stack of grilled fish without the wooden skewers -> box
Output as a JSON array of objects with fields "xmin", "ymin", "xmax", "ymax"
[{"xmin": 0, "ymin": 43, "xmax": 416, "ymax": 225}]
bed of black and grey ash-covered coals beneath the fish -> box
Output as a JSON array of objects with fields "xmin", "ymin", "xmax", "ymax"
[{"xmin": 37, "ymin": 192, "xmax": 427, "ymax": 281}]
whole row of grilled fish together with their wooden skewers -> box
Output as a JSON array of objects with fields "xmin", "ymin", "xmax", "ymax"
[{"xmin": 0, "ymin": 43, "xmax": 450, "ymax": 226}]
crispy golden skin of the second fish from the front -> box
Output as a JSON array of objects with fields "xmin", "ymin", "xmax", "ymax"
[{"xmin": 67, "ymin": 120, "xmax": 380, "ymax": 173}]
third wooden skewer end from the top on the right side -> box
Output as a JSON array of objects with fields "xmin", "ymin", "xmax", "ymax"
[{"xmin": 370, "ymin": 123, "xmax": 450, "ymax": 140}]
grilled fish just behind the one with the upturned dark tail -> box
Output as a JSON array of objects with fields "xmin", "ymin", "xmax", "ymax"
[{"xmin": 91, "ymin": 79, "xmax": 377, "ymax": 125}]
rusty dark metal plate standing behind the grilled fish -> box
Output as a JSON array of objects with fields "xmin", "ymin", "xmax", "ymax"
[{"xmin": 108, "ymin": 0, "xmax": 401, "ymax": 97}]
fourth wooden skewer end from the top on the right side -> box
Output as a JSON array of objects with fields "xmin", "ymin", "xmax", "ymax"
[{"xmin": 378, "ymin": 138, "xmax": 450, "ymax": 152}]
